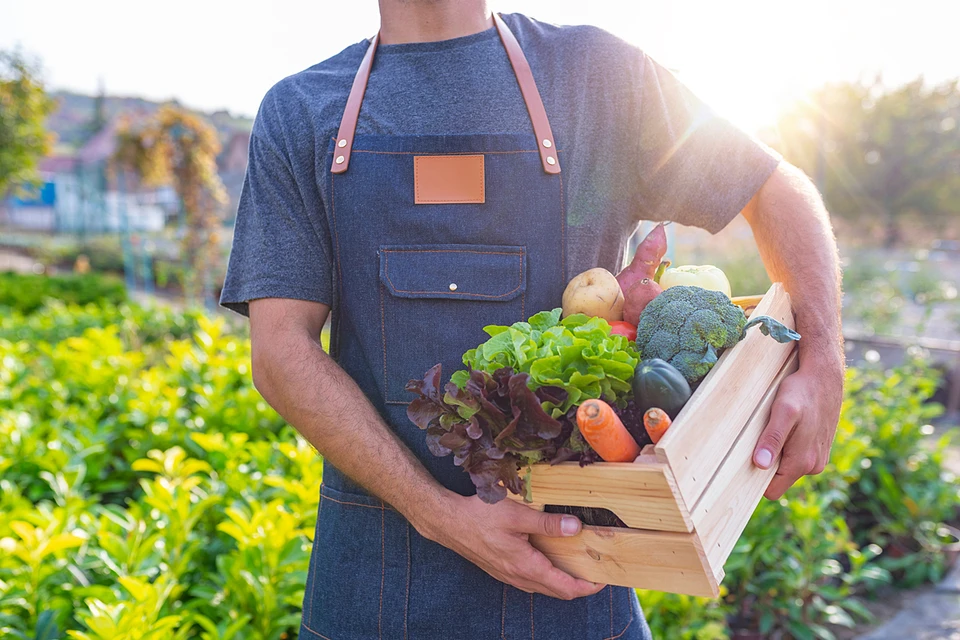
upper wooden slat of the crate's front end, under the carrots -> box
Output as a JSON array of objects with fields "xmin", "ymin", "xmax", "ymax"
[{"xmin": 511, "ymin": 460, "xmax": 693, "ymax": 531}]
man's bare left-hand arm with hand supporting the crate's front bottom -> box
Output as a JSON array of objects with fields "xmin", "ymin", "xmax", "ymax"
[{"xmin": 250, "ymin": 298, "xmax": 603, "ymax": 599}]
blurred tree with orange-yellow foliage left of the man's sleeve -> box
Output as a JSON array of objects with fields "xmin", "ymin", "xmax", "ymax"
[{"xmin": 113, "ymin": 105, "xmax": 227, "ymax": 299}]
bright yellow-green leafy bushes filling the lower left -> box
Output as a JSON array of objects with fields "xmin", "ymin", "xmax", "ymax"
[{"xmin": 0, "ymin": 305, "xmax": 322, "ymax": 640}]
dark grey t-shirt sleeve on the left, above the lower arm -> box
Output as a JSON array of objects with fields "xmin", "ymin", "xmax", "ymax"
[{"xmin": 220, "ymin": 109, "xmax": 333, "ymax": 315}]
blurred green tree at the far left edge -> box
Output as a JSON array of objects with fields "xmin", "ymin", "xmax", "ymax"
[{"xmin": 0, "ymin": 51, "xmax": 54, "ymax": 197}]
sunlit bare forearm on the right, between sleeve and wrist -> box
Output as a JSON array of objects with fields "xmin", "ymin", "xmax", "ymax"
[{"xmin": 743, "ymin": 162, "xmax": 844, "ymax": 370}]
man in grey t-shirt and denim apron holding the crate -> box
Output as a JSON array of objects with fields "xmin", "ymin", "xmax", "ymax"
[{"xmin": 222, "ymin": 0, "xmax": 843, "ymax": 640}]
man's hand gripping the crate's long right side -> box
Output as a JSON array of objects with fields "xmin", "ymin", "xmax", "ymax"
[{"xmin": 753, "ymin": 356, "xmax": 843, "ymax": 500}]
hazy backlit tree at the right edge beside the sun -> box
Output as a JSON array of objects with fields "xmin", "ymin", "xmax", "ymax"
[{"xmin": 775, "ymin": 78, "xmax": 960, "ymax": 246}]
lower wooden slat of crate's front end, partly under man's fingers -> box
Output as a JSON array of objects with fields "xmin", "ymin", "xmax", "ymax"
[{"xmin": 530, "ymin": 527, "xmax": 723, "ymax": 597}]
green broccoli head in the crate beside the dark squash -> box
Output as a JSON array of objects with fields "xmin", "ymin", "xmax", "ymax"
[{"xmin": 637, "ymin": 287, "xmax": 747, "ymax": 384}]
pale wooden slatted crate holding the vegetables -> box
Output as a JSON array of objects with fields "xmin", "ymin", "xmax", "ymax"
[{"xmin": 511, "ymin": 284, "xmax": 798, "ymax": 596}]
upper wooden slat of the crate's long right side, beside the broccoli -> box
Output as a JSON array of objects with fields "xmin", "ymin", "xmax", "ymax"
[{"xmin": 656, "ymin": 283, "xmax": 794, "ymax": 505}]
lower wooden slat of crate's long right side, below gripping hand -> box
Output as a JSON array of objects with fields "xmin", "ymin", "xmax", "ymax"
[{"xmin": 693, "ymin": 349, "xmax": 799, "ymax": 569}]
